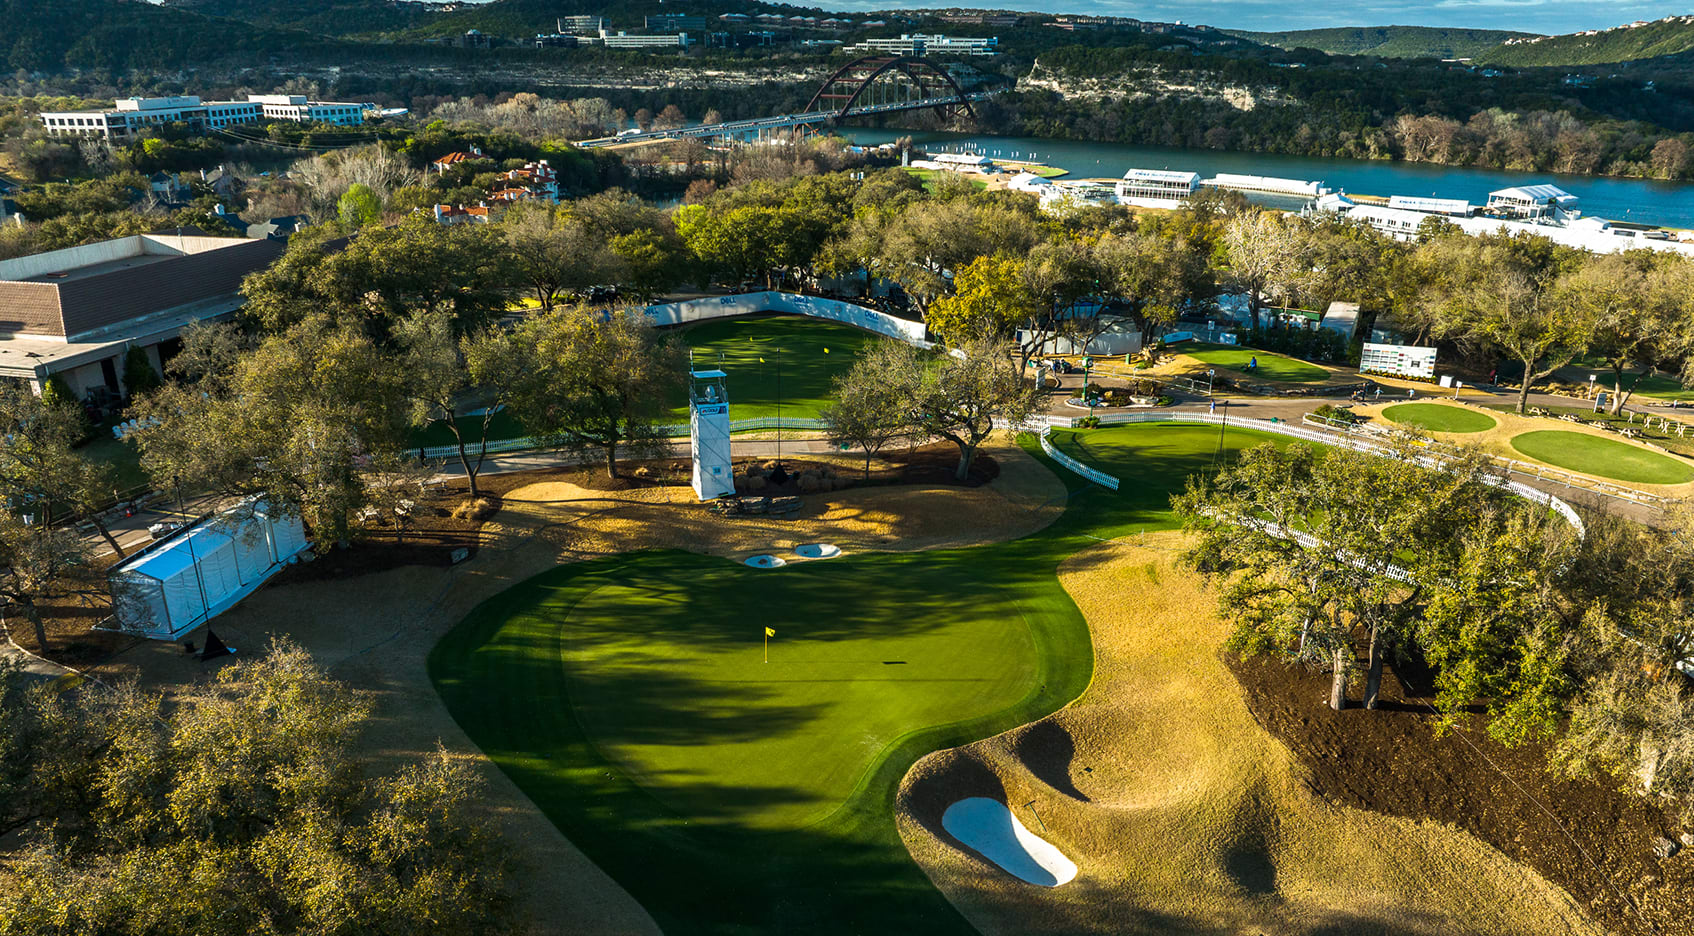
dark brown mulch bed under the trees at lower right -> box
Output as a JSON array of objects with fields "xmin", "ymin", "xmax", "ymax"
[{"xmin": 1225, "ymin": 653, "xmax": 1694, "ymax": 934}]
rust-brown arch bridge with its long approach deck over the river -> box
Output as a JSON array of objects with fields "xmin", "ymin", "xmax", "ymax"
[{"xmin": 576, "ymin": 56, "xmax": 996, "ymax": 147}]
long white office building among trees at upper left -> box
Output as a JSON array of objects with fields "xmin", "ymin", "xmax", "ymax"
[{"xmin": 41, "ymin": 95, "xmax": 374, "ymax": 144}]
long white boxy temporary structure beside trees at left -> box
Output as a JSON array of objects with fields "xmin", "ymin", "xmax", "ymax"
[{"xmin": 107, "ymin": 503, "xmax": 308, "ymax": 640}]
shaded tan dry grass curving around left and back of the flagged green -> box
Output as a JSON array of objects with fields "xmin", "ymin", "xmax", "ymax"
[{"xmin": 85, "ymin": 443, "xmax": 1064, "ymax": 936}]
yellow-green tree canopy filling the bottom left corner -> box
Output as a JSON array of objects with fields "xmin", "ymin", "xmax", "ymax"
[{"xmin": 0, "ymin": 645, "xmax": 513, "ymax": 936}]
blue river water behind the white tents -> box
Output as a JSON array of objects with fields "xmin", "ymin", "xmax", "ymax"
[{"xmin": 837, "ymin": 127, "xmax": 1694, "ymax": 228}]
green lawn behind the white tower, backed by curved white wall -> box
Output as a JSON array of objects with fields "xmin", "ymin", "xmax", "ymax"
[{"xmin": 671, "ymin": 315, "xmax": 884, "ymax": 423}]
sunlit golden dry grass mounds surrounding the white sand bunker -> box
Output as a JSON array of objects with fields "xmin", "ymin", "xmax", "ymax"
[{"xmin": 898, "ymin": 533, "xmax": 1597, "ymax": 934}]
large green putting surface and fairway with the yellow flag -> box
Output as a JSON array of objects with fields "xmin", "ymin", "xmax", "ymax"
[{"xmin": 429, "ymin": 424, "xmax": 1264, "ymax": 934}]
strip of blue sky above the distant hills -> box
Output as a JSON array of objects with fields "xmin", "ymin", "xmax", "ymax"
[{"xmin": 826, "ymin": 0, "xmax": 1694, "ymax": 34}]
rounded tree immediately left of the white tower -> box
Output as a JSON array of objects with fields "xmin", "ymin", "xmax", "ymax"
[{"xmin": 510, "ymin": 308, "xmax": 688, "ymax": 477}]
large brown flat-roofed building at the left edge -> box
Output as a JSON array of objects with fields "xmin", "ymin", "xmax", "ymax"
[{"xmin": 0, "ymin": 234, "xmax": 285, "ymax": 401}]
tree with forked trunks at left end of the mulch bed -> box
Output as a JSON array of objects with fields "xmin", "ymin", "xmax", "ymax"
[{"xmin": 1172, "ymin": 440, "xmax": 1524, "ymax": 709}]
